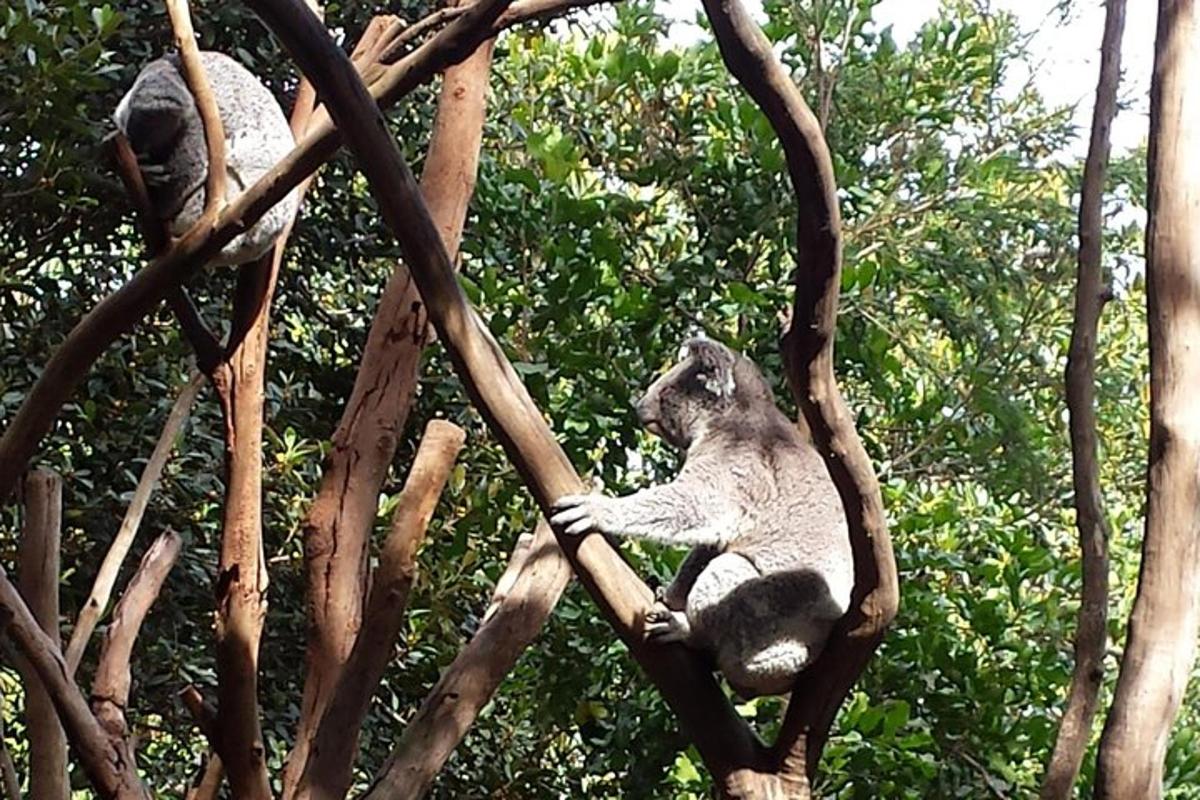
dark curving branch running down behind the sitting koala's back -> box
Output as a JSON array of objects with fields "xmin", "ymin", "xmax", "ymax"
[{"xmin": 703, "ymin": 0, "xmax": 899, "ymax": 784}]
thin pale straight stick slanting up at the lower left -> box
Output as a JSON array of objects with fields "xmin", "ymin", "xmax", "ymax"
[{"xmin": 66, "ymin": 372, "xmax": 204, "ymax": 676}]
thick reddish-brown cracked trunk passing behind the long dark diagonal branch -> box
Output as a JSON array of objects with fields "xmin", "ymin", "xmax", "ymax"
[{"xmin": 283, "ymin": 18, "xmax": 492, "ymax": 796}]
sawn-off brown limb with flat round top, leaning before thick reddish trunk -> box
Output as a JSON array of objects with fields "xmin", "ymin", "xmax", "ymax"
[{"xmin": 296, "ymin": 420, "xmax": 467, "ymax": 800}]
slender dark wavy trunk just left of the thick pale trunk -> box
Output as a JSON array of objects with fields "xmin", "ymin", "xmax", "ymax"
[{"xmin": 1042, "ymin": 0, "xmax": 1126, "ymax": 800}]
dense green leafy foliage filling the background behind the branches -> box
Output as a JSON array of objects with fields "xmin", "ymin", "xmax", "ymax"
[{"xmin": 0, "ymin": 0, "xmax": 1200, "ymax": 798}]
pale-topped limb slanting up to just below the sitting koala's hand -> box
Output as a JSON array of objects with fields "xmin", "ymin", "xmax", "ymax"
[{"xmin": 365, "ymin": 519, "xmax": 571, "ymax": 800}]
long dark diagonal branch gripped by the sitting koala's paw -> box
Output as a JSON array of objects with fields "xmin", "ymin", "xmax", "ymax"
[{"xmin": 250, "ymin": 0, "xmax": 762, "ymax": 791}]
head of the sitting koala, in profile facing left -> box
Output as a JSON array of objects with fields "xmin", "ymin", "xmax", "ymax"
[{"xmin": 637, "ymin": 338, "xmax": 738, "ymax": 450}]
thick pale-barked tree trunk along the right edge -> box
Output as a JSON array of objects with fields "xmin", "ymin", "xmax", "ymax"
[{"xmin": 1096, "ymin": 0, "xmax": 1200, "ymax": 800}]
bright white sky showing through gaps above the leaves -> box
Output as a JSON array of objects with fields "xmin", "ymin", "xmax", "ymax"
[{"xmin": 656, "ymin": 0, "xmax": 1157, "ymax": 157}]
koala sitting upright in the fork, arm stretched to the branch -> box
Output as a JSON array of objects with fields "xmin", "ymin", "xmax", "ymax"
[{"xmin": 551, "ymin": 338, "xmax": 854, "ymax": 698}]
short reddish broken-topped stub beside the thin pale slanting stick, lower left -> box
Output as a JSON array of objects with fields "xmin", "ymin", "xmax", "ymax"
[{"xmin": 91, "ymin": 530, "xmax": 182, "ymax": 738}]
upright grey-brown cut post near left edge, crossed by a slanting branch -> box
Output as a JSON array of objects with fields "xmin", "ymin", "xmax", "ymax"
[{"xmin": 17, "ymin": 469, "xmax": 71, "ymax": 800}]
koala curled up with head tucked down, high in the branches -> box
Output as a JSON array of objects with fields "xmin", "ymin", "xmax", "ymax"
[{"xmin": 113, "ymin": 50, "xmax": 296, "ymax": 266}]
